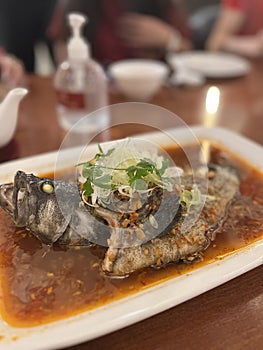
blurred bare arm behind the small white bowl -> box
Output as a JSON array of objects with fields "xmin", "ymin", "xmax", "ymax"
[{"xmin": 119, "ymin": 13, "xmax": 174, "ymax": 49}]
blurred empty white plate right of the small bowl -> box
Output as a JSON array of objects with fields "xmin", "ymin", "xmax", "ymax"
[{"xmin": 167, "ymin": 51, "xmax": 250, "ymax": 78}]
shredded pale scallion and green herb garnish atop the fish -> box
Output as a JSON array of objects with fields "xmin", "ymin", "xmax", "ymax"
[{"xmin": 77, "ymin": 145, "xmax": 215, "ymax": 210}]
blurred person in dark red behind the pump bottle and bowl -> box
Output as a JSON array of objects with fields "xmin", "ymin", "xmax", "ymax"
[{"xmin": 54, "ymin": 0, "xmax": 194, "ymax": 64}]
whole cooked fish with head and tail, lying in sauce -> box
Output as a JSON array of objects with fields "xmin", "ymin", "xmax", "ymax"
[{"xmin": 0, "ymin": 166, "xmax": 239, "ymax": 276}]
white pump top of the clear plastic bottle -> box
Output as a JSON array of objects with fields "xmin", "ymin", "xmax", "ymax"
[{"xmin": 68, "ymin": 13, "xmax": 90, "ymax": 60}]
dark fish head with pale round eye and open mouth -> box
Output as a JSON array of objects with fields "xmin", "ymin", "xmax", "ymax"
[{"xmin": 0, "ymin": 171, "xmax": 79, "ymax": 244}]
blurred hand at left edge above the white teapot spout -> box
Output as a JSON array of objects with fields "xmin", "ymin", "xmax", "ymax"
[{"xmin": 0, "ymin": 50, "xmax": 25, "ymax": 88}]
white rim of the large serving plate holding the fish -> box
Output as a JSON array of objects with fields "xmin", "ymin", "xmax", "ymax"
[{"xmin": 0, "ymin": 127, "xmax": 263, "ymax": 350}]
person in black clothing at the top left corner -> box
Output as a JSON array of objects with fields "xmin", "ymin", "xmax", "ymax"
[{"xmin": 0, "ymin": 0, "xmax": 57, "ymax": 72}]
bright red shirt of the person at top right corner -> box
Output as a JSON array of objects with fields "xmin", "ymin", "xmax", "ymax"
[{"xmin": 222, "ymin": 0, "xmax": 263, "ymax": 35}]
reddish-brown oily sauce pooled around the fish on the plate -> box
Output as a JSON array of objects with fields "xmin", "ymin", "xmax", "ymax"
[{"xmin": 0, "ymin": 141, "xmax": 263, "ymax": 327}]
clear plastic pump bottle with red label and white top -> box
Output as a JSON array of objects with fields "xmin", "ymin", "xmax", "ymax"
[{"xmin": 54, "ymin": 13, "xmax": 109, "ymax": 136}]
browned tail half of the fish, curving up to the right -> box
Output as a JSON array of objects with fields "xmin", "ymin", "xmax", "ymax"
[{"xmin": 102, "ymin": 167, "xmax": 239, "ymax": 276}]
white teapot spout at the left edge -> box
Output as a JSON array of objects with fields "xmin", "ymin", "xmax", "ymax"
[{"xmin": 0, "ymin": 88, "xmax": 28, "ymax": 147}]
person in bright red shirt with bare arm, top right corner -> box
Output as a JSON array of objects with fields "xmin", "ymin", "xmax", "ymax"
[{"xmin": 206, "ymin": 0, "xmax": 263, "ymax": 58}]
